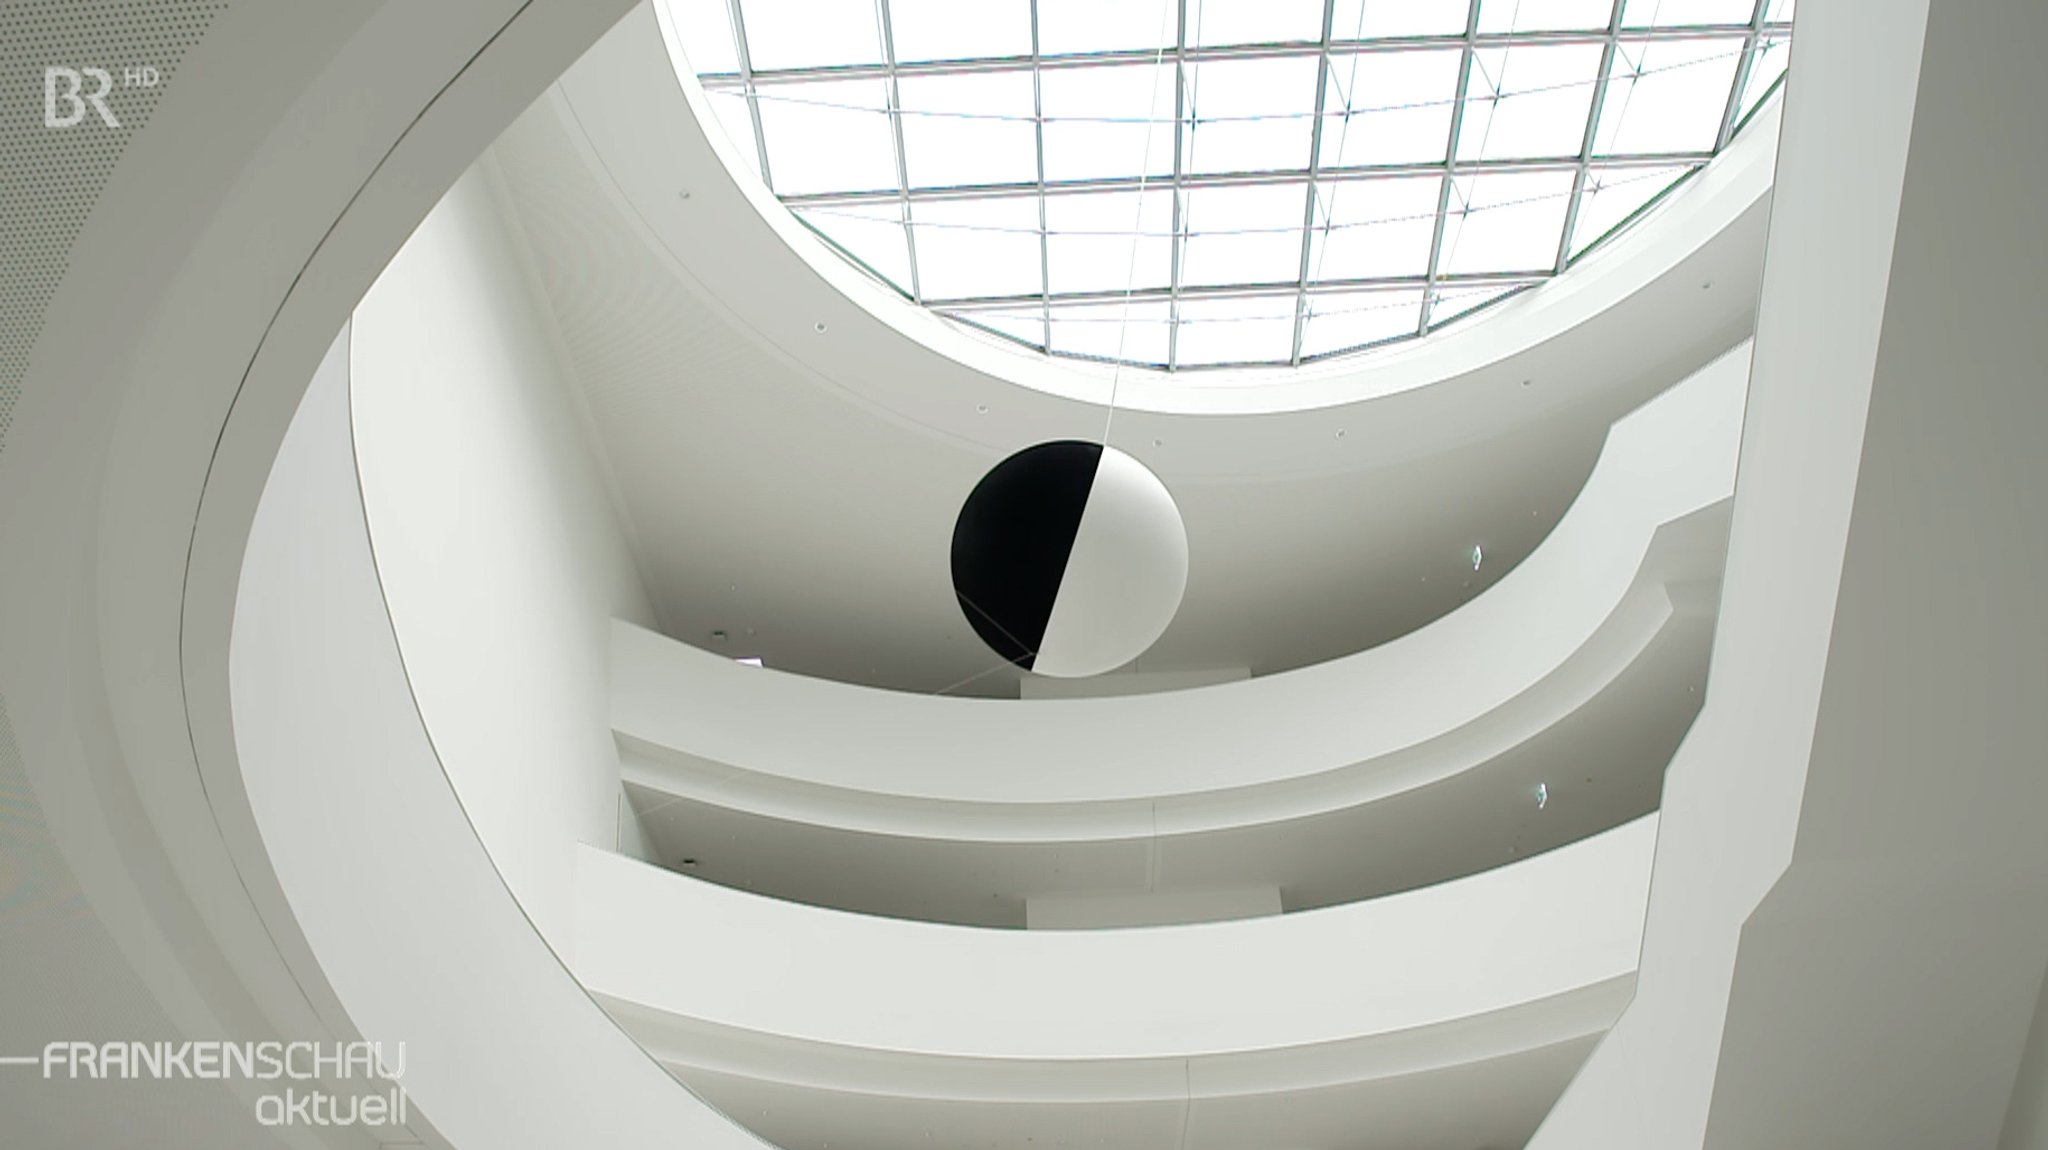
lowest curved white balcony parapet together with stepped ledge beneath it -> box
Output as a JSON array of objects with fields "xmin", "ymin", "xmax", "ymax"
[{"xmin": 575, "ymin": 814, "xmax": 1657, "ymax": 1121}]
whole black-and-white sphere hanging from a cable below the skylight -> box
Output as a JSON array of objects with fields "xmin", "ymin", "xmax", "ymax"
[{"xmin": 952, "ymin": 440, "xmax": 1188, "ymax": 679}]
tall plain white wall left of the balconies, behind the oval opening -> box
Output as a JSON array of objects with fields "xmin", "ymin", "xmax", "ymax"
[{"xmin": 350, "ymin": 162, "xmax": 653, "ymax": 949}]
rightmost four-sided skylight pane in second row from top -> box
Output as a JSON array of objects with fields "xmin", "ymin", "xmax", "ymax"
[{"xmin": 1593, "ymin": 39, "xmax": 1743, "ymax": 156}]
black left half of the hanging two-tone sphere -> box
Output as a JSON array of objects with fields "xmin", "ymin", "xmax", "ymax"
[{"xmin": 952, "ymin": 440, "xmax": 1102, "ymax": 671}]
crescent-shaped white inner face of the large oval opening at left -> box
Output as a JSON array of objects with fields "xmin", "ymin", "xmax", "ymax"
[{"xmin": 229, "ymin": 323, "xmax": 758, "ymax": 1148}]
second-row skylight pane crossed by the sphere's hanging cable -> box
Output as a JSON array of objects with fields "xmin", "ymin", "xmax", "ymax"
[{"xmin": 1038, "ymin": 63, "xmax": 1174, "ymax": 180}]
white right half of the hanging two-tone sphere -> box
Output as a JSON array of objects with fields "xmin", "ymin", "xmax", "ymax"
[{"xmin": 1032, "ymin": 437, "xmax": 1188, "ymax": 679}]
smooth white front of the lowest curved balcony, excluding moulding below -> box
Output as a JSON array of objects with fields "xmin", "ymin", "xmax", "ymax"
[{"xmin": 575, "ymin": 814, "xmax": 1657, "ymax": 1060}]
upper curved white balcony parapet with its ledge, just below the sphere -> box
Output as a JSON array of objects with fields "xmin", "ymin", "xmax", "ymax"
[{"xmin": 612, "ymin": 335, "xmax": 1747, "ymax": 818}]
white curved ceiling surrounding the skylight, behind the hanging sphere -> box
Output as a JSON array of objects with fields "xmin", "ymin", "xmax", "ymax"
[{"xmin": 479, "ymin": 24, "xmax": 1774, "ymax": 696}]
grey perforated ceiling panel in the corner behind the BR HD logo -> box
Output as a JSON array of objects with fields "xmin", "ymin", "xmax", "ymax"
[{"xmin": 0, "ymin": 0, "xmax": 227, "ymax": 448}]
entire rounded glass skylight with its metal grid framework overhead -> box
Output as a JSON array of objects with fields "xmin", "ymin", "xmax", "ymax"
[{"xmin": 668, "ymin": 0, "xmax": 1792, "ymax": 370}]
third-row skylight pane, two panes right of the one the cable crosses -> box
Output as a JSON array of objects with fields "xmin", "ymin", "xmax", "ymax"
[{"xmin": 1309, "ymin": 176, "xmax": 1444, "ymax": 282}]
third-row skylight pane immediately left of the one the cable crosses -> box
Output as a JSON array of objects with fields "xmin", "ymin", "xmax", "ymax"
[{"xmin": 909, "ymin": 196, "xmax": 1042, "ymax": 299}]
